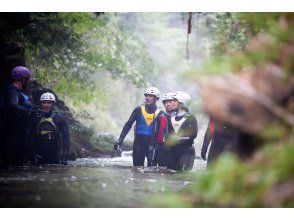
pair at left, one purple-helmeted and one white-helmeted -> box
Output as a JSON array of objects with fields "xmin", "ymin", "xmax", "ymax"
[{"xmin": 1, "ymin": 66, "xmax": 70, "ymax": 166}]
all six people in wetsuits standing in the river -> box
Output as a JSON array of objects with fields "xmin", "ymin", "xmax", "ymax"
[{"xmin": 0, "ymin": 66, "xmax": 233, "ymax": 171}]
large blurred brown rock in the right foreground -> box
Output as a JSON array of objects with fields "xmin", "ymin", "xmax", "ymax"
[{"xmin": 202, "ymin": 69, "xmax": 294, "ymax": 134}]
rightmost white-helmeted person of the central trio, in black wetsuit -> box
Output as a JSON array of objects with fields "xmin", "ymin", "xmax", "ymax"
[{"xmin": 165, "ymin": 91, "xmax": 198, "ymax": 171}]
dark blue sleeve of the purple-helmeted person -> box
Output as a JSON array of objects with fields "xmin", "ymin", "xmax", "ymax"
[{"xmin": 7, "ymin": 90, "xmax": 30, "ymax": 117}]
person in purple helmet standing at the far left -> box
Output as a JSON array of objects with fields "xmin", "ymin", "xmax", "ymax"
[{"xmin": 3, "ymin": 66, "xmax": 33, "ymax": 165}]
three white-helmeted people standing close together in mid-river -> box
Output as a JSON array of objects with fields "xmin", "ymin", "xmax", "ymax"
[{"xmin": 114, "ymin": 87, "xmax": 198, "ymax": 170}]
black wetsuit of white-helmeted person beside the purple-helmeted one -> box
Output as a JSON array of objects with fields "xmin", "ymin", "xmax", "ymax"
[{"xmin": 29, "ymin": 112, "xmax": 70, "ymax": 164}]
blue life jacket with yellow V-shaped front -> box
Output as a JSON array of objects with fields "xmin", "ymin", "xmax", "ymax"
[{"xmin": 135, "ymin": 105, "xmax": 161, "ymax": 136}]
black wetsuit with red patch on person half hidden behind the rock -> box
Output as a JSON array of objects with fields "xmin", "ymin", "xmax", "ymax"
[{"xmin": 201, "ymin": 120, "xmax": 237, "ymax": 165}]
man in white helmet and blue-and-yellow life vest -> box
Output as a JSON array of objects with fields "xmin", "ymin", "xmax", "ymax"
[{"xmin": 114, "ymin": 87, "xmax": 166, "ymax": 166}]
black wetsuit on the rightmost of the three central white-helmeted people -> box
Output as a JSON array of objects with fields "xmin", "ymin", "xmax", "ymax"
[{"xmin": 163, "ymin": 114, "xmax": 198, "ymax": 170}]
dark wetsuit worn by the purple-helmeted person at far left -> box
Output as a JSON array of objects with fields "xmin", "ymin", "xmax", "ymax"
[{"xmin": 4, "ymin": 84, "xmax": 33, "ymax": 165}]
